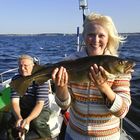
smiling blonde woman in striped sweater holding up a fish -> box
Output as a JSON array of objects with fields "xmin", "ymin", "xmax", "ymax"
[{"xmin": 52, "ymin": 13, "xmax": 131, "ymax": 140}]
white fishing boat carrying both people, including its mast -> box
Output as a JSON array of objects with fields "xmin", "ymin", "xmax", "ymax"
[{"xmin": 0, "ymin": 0, "xmax": 140, "ymax": 140}]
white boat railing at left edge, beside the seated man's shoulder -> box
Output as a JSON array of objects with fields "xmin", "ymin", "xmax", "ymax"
[{"xmin": 0, "ymin": 68, "xmax": 18, "ymax": 89}]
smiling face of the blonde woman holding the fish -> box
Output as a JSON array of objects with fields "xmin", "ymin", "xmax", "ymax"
[{"xmin": 84, "ymin": 23, "xmax": 109, "ymax": 56}]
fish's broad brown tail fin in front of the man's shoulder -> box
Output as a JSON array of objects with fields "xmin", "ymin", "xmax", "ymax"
[{"xmin": 10, "ymin": 77, "xmax": 33, "ymax": 96}]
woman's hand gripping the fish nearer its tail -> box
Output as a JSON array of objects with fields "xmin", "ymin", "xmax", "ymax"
[{"xmin": 52, "ymin": 67, "xmax": 68, "ymax": 87}]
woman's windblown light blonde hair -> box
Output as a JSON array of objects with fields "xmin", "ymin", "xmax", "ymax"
[{"xmin": 83, "ymin": 13, "xmax": 126, "ymax": 55}]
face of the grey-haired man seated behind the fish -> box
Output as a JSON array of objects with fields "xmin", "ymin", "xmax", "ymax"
[{"xmin": 19, "ymin": 59, "xmax": 34, "ymax": 76}]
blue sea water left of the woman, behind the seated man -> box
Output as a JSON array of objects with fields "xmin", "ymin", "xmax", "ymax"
[{"xmin": 0, "ymin": 34, "xmax": 76, "ymax": 72}]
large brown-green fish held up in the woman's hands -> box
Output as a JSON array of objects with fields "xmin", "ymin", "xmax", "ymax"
[{"xmin": 10, "ymin": 55, "xmax": 135, "ymax": 95}]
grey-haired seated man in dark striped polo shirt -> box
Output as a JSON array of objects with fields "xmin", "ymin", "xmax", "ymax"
[{"xmin": 11, "ymin": 55, "xmax": 51, "ymax": 139}]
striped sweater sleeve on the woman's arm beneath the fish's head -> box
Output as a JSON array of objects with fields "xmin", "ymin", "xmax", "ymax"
[{"xmin": 109, "ymin": 74, "xmax": 131, "ymax": 118}]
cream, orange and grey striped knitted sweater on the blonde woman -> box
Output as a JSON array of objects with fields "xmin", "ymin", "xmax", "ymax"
[{"xmin": 56, "ymin": 49, "xmax": 131, "ymax": 140}]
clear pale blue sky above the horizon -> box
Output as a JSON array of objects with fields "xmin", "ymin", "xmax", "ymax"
[{"xmin": 0, "ymin": 0, "xmax": 140, "ymax": 34}]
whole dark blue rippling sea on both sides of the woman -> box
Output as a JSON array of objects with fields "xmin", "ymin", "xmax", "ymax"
[{"xmin": 0, "ymin": 33, "xmax": 140, "ymax": 137}]
